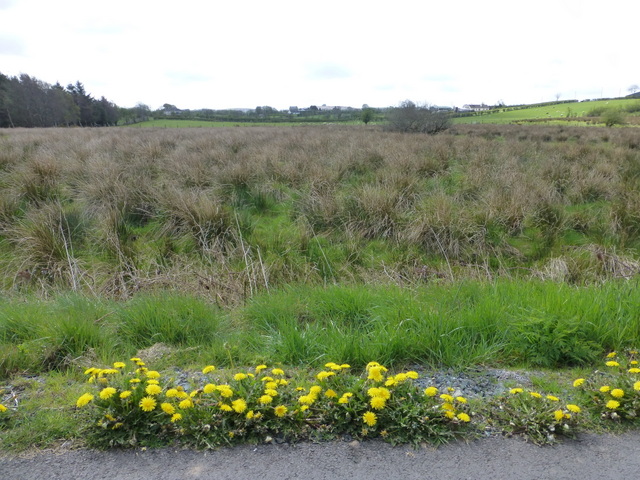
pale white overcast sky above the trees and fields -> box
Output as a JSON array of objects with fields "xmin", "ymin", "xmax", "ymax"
[{"xmin": 0, "ymin": 0, "xmax": 640, "ymax": 109}]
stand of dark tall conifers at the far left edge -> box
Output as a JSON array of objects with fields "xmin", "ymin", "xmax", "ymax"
[{"xmin": 0, "ymin": 73, "xmax": 121, "ymax": 128}]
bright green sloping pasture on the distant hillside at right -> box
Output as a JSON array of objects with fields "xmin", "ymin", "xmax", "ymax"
[{"xmin": 454, "ymin": 99, "xmax": 640, "ymax": 125}]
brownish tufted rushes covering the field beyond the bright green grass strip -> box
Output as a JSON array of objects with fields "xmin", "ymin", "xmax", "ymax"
[{"xmin": 0, "ymin": 125, "xmax": 640, "ymax": 298}]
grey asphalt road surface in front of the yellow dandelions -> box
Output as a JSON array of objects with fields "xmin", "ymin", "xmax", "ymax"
[{"xmin": 0, "ymin": 432, "xmax": 640, "ymax": 480}]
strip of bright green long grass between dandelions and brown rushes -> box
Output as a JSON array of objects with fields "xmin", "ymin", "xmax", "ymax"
[{"xmin": 0, "ymin": 281, "xmax": 640, "ymax": 377}]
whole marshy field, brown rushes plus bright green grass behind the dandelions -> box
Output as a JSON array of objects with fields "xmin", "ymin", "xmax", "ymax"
[{"xmin": 0, "ymin": 125, "xmax": 640, "ymax": 450}]
